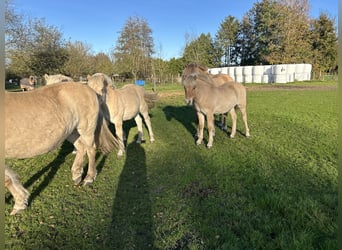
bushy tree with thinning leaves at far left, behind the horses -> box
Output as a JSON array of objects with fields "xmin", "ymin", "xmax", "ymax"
[{"xmin": 6, "ymin": 16, "xmax": 68, "ymax": 77}]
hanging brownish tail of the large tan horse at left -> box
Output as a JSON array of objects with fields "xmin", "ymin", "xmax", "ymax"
[{"xmin": 95, "ymin": 109, "xmax": 119, "ymax": 154}]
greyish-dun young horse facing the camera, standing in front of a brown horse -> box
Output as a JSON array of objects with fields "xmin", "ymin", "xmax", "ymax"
[{"xmin": 183, "ymin": 73, "xmax": 250, "ymax": 148}]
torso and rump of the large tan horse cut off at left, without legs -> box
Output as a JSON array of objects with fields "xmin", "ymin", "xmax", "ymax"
[{"xmin": 5, "ymin": 83, "xmax": 98, "ymax": 158}]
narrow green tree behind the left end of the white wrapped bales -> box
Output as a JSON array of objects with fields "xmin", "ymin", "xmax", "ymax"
[{"xmin": 215, "ymin": 16, "xmax": 239, "ymax": 66}]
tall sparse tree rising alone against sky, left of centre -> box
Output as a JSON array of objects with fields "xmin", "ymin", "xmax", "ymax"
[{"xmin": 113, "ymin": 17, "xmax": 154, "ymax": 79}]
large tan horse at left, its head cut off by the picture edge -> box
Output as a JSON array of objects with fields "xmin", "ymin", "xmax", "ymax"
[{"xmin": 5, "ymin": 82, "xmax": 118, "ymax": 215}]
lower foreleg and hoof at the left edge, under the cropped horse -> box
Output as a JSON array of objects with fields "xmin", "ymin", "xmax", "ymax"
[{"xmin": 5, "ymin": 166, "xmax": 29, "ymax": 215}]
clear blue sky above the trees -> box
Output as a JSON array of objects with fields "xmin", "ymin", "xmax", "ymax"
[{"xmin": 12, "ymin": 0, "xmax": 338, "ymax": 60}]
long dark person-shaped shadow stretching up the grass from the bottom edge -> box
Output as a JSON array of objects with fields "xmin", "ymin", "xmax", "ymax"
[{"xmin": 105, "ymin": 141, "xmax": 153, "ymax": 249}]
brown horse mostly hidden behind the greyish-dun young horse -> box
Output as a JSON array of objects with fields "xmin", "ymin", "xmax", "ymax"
[{"xmin": 182, "ymin": 63, "xmax": 246, "ymax": 131}]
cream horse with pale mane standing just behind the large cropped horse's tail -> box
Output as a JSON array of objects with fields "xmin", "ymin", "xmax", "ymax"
[{"xmin": 87, "ymin": 73, "xmax": 158, "ymax": 156}]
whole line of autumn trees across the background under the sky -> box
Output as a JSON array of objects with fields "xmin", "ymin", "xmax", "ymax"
[{"xmin": 5, "ymin": 0, "xmax": 338, "ymax": 83}]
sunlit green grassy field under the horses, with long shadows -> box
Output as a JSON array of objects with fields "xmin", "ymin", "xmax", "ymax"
[{"xmin": 5, "ymin": 82, "xmax": 337, "ymax": 249}]
